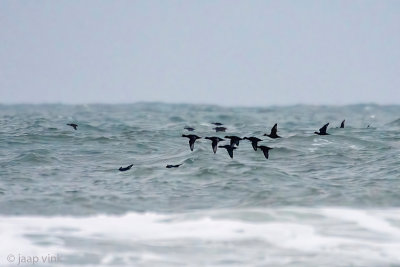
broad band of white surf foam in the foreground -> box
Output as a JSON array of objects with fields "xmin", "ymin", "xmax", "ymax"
[{"xmin": 0, "ymin": 208, "xmax": 400, "ymax": 266}]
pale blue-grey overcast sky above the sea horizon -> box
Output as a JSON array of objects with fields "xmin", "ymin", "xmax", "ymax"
[{"xmin": 0, "ymin": 0, "xmax": 400, "ymax": 106}]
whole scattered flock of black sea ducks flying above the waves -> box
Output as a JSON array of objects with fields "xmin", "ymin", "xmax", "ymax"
[{"xmin": 67, "ymin": 120, "xmax": 346, "ymax": 172}]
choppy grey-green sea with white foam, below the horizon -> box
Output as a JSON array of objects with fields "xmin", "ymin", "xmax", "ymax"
[{"xmin": 0, "ymin": 103, "xmax": 400, "ymax": 267}]
